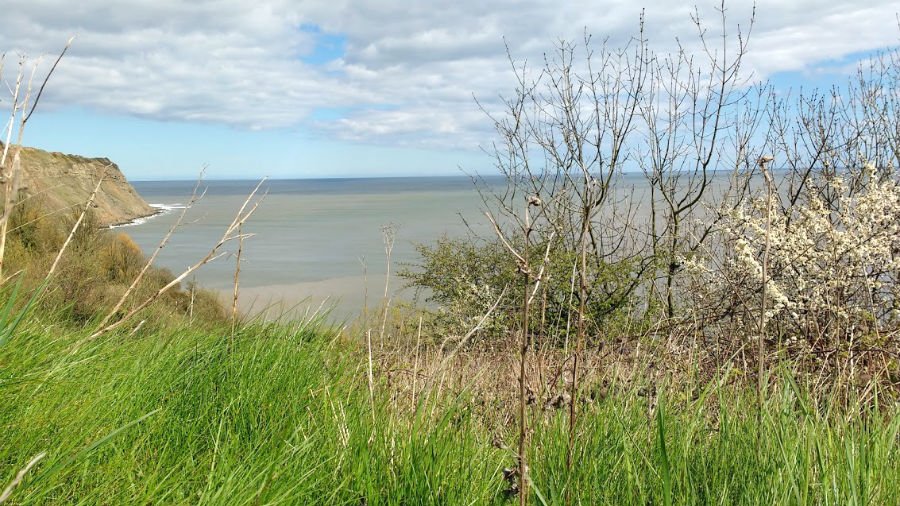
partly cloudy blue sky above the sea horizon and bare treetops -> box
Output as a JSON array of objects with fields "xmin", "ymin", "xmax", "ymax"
[{"xmin": 0, "ymin": 0, "xmax": 900, "ymax": 180}]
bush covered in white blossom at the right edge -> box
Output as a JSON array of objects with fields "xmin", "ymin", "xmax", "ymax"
[{"xmin": 687, "ymin": 164, "xmax": 900, "ymax": 350}]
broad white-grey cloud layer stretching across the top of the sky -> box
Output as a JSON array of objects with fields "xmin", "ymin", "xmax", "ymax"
[{"xmin": 0, "ymin": 0, "xmax": 900, "ymax": 148}]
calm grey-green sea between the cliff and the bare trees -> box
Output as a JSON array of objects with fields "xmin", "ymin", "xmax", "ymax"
[{"xmin": 121, "ymin": 177, "xmax": 502, "ymax": 318}]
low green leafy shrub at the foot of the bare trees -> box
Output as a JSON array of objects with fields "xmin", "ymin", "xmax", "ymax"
[{"xmin": 400, "ymin": 237, "xmax": 637, "ymax": 345}]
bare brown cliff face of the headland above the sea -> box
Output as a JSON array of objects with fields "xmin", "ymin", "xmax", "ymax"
[{"xmin": 2, "ymin": 143, "xmax": 156, "ymax": 226}]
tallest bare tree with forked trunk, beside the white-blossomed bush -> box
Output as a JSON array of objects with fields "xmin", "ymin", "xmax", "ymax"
[{"xmin": 635, "ymin": 2, "xmax": 771, "ymax": 318}]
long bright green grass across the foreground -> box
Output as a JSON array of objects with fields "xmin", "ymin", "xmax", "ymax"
[{"xmin": 0, "ymin": 311, "xmax": 900, "ymax": 505}]
